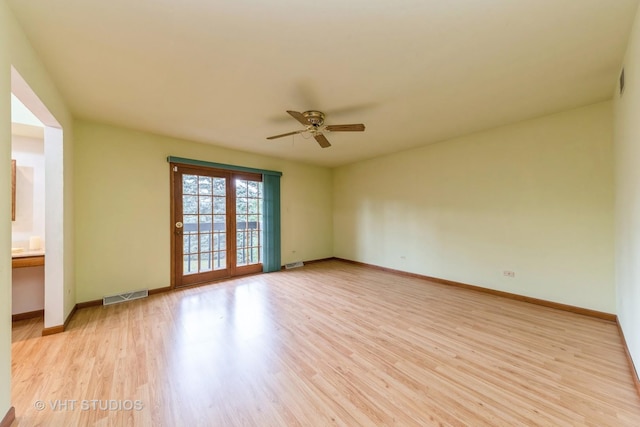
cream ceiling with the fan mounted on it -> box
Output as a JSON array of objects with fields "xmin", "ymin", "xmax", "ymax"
[{"xmin": 8, "ymin": 0, "xmax": 638, "ymax": 166}]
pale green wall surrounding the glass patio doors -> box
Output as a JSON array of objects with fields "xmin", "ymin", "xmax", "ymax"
[{"xmin": 74, "ymin": 121, "xmax": 333, "ymax": 302}]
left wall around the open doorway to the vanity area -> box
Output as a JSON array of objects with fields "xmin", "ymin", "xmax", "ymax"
[{"xmin": 0, "ymin": 0, "xmax": 75, "ymax": 418}]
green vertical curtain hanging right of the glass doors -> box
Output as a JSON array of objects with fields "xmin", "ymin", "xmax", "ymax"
[{"xmin": 262, "ymin": 174, "xmax": 281, "ymax": 273}]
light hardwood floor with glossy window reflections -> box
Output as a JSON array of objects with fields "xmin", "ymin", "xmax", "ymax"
[{"xmin": 12, "ymin": 261, "xmax": 640, "ymax": 426}]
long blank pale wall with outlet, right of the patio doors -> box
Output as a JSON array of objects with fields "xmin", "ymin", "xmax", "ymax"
[{"xmin": 333, "ymin": 102, "xmax": 615, "ymax": 313}]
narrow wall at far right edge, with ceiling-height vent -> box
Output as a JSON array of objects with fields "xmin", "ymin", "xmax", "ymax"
[{"xmin": 613, "ymin": 5, "xmax": 640, "ymax": 382}]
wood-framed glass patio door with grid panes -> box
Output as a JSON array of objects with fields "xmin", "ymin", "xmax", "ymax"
[{"xmin": 171, "ymin": 164, "xmax": 264, "ymax": 286}]
